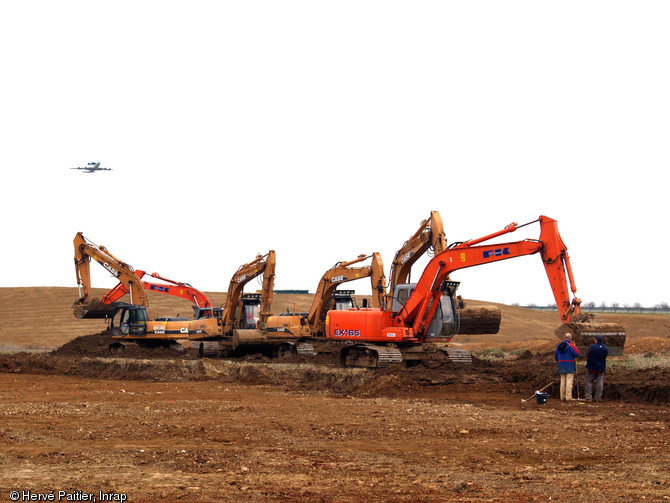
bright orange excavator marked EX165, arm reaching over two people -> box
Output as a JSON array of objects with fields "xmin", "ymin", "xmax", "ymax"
[{"xmin": 326, "ymin": 216, "xmax": 626, "ymax": 367}]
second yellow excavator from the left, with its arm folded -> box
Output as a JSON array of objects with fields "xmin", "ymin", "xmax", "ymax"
[{"xmin": 188, "ymin": 250, "xmax": 277, "ymax": 356}]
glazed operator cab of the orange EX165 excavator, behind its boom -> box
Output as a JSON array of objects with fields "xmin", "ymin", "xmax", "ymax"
[{"xmin": 393, "ymin": 281, "xmax": 460, "ymax": 342}]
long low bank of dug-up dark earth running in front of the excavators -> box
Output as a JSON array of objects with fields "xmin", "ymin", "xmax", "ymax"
[{"xmin": 0, "ymin": 353, "xmax": 670, "ymax": 404}]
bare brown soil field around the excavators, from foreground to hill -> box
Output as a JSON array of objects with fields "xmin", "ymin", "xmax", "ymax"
[{"xmin": 0, "ymin": 288, "xmax": 670, "ymax": 502}]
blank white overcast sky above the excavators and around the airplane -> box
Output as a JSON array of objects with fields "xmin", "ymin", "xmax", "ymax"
[{"xmin": 0, "ymin": 0, "xmax": 670, "ymax": 306}]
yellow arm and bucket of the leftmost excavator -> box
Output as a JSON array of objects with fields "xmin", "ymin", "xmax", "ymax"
[{"xmin": 72, "ymin": 232, "xmax": 149, "ymax": 318}]
